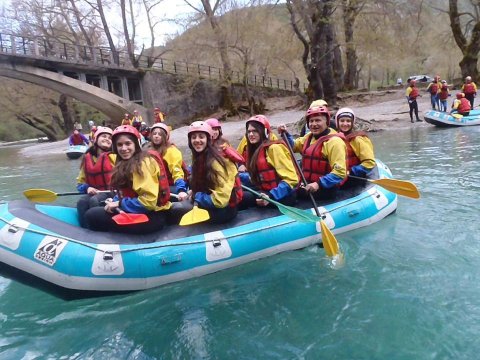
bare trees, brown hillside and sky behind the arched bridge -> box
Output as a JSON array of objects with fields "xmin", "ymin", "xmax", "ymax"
[{"xmin": 0, "ymin": 0, "xmax": 480, "ymax": 140}]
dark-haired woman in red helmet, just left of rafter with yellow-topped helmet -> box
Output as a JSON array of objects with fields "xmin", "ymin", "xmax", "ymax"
[{"xmin": 240, "ymin": 115, "xmax": 299, "ymax": 208}]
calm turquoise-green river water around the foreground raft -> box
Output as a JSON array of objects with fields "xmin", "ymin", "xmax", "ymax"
[{"xmin": 0, "ymin": 127, "xmax": 480, "ymax": 360}]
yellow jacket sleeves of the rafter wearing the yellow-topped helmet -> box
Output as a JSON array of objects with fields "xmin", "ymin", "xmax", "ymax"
[{"xmin": 293, "ymin": 128, "xmax": 347, "ymax": 179}]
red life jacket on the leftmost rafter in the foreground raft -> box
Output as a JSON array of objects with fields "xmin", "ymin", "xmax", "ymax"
[{"xmin": 83, "ymin": 152, "xmax": 113, "ymax": 190}]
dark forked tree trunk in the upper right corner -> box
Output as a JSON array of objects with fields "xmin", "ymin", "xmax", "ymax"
[{"xmin": 448, "ymin": 0, "xmax": 480, "ymax": 80}]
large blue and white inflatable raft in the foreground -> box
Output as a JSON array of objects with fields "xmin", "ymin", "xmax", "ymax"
[{"xmin": 0, "ymin": 160, "xmax": 412, "ymax": 292}]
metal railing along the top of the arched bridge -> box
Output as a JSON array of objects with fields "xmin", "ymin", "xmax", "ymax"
[{"xmin": 0, "ymin": 33, "xmax": 307, "ymax": 91}]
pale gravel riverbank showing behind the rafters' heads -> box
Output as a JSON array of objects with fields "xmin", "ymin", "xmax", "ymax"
[{"xmin": 21, "ymin": 89, "xmax": 430, "ymax": 157}]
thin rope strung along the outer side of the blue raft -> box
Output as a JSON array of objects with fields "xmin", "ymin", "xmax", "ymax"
[{"xmin": 0, "ymin": 191, "xmax": 378, "ymax": 254}]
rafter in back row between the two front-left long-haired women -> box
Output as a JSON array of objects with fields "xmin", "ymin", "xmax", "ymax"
[{"xmin": 144, "ymin": 123, "xmax": 189, "ymax": 201}]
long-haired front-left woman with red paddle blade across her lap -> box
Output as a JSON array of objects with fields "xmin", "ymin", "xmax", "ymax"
[{"xmin": 85, "ymin": 125, "xmax": 172, "ymax": 234}]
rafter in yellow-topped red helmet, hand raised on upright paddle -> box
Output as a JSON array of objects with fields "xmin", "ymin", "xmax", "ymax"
[{"xmin": 278, "ymin": 106, "xmax": 347, "ymax": 199}]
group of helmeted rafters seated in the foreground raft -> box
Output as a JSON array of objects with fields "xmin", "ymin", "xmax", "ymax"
[{"xmin": 77, "ymin": 100, "xmax": 376, "ymax": 234}]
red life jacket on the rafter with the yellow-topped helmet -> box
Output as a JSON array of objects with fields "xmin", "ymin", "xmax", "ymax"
[{"xmin": 302, "ymin": 133, "xmax": 341, "ymax": 183}]
